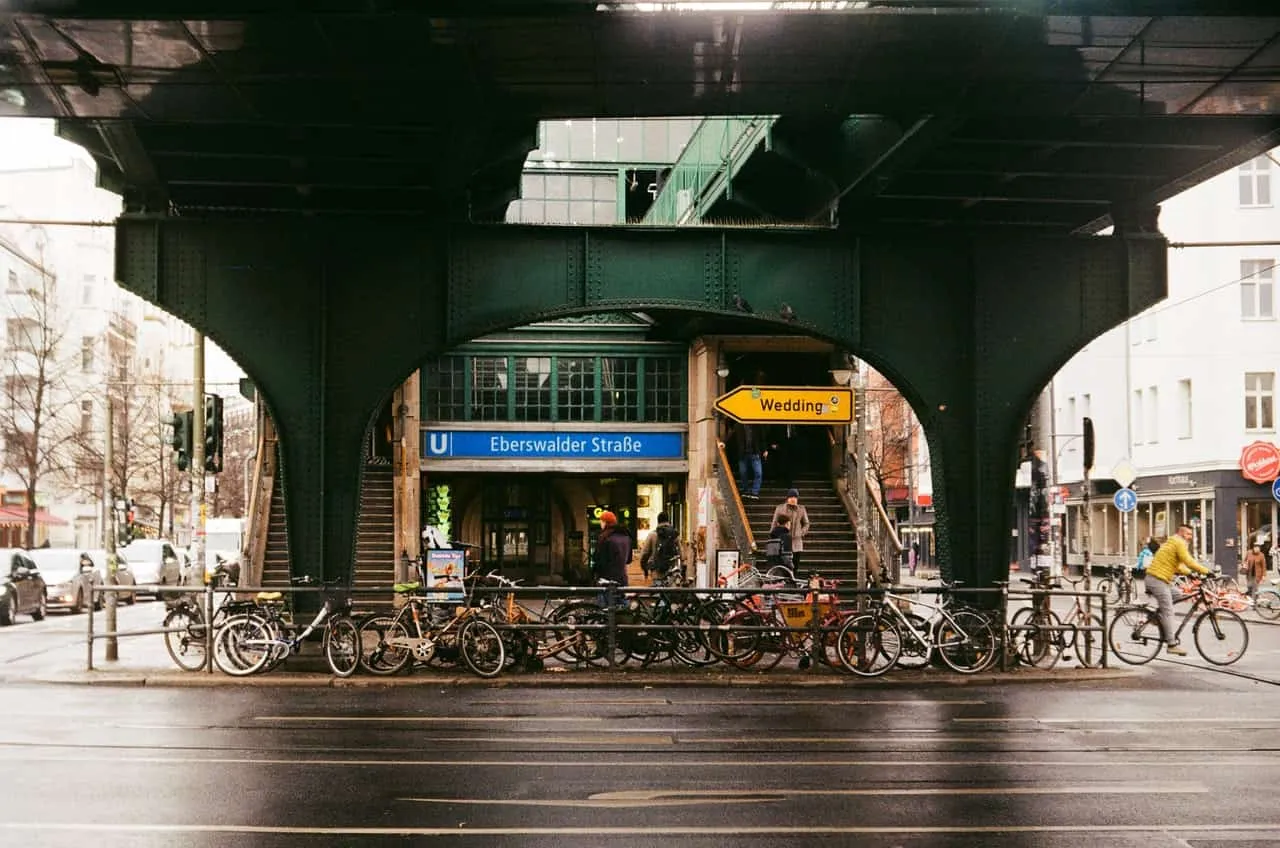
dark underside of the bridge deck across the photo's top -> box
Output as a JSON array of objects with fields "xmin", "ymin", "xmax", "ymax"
[{"xmin": 0, "ymin": 0, "xmax": 1280, "ymax": 233}]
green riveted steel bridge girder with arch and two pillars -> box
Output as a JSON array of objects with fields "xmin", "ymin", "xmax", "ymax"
[{"xmin": 116, "ymin": 216, "xmax": 1166, "ymax": 585}]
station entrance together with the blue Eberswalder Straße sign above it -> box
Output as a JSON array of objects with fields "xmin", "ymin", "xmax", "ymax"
[{"xmin": 421, "ymin": 424, "xmax": 687, "ymax": 584}]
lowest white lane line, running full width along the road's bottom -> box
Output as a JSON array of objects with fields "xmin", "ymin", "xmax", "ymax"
[{"xmin": 0, "ymin": 821, "xmax": 1280, "ymax": 839}]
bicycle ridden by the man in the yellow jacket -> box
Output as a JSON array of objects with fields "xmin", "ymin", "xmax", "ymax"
[{"xmin": 1107, "ymin": 573, "xmax": 1249, "ymax": 666}]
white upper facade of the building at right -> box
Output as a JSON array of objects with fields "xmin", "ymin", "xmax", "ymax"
[{"xmin": 1053, "ymin": 153, "xmax": 1280, "ymax": 482}]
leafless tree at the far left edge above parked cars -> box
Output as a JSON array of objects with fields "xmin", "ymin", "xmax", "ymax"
[{"xmin": 0, "ymin": 249, "xmax": 79, "ymax": 547}]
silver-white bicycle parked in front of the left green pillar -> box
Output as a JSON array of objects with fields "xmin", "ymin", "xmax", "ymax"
[{"xmin": 214, "ymin": 578, "xmax": 360, "ymax": 678}]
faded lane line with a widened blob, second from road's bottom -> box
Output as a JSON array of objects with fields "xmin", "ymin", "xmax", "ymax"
[{"xmin": 397, "ymin": 780, "xmax": 1210, "ymax": 808}]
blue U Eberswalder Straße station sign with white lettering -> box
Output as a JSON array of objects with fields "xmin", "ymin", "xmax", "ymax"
[{"xmin": 422, "ymin": 430, "xmax": 685, "ymax": 460}]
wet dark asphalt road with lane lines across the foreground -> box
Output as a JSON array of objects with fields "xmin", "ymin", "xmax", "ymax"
[{"xmin": 0, "ymin": 669, "xmax": 1280, "ymax": 848}]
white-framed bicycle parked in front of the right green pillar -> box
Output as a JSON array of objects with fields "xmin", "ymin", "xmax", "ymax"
[{"xmin": 836, "ymin": 591, "xmax": 997, "ymax": 678}]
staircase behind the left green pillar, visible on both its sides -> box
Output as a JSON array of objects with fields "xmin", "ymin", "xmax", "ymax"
[{"xmin": 262, "ymin": 465, "xmax": 396, "ymax": 612}]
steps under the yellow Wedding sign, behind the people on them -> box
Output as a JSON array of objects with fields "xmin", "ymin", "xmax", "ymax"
[{"xmin": 742, "ymin": 478, "xmax": 858, "ymax": 583}]
